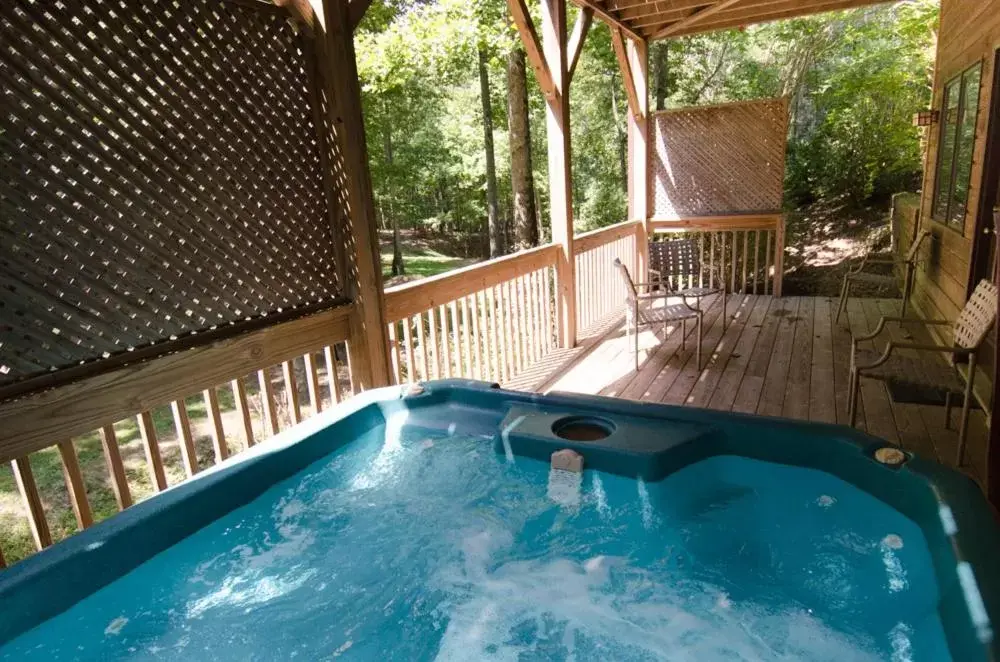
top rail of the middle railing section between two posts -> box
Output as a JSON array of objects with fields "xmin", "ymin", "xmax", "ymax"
[{"xmin": 385, "ymin": 244, "xmax": 559, "ymax": 323}]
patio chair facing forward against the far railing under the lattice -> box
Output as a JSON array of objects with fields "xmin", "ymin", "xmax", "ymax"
[{"xmin": 649, "ymin": 239, "xmax": 729, "ymax": 329}]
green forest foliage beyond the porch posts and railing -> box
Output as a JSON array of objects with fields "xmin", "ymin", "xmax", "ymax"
[{"xmin": 356, "ymin": 0, "xmax": 938, "ymax": 260}]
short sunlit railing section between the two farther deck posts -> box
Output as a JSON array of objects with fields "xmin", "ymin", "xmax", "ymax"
[{"xmin": 573, "ymin": 221, "xmax": 642, "ymax": 333}]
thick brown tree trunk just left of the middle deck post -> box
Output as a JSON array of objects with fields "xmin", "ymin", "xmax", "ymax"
[{"xmin": 507, "ymin": 44, "xmax": 538, "ymax": 251}]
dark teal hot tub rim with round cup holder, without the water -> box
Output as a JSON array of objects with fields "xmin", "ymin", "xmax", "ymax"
[{"xmin": 0, "ymin": 380, "xmax": 1000, "ymax": 661}]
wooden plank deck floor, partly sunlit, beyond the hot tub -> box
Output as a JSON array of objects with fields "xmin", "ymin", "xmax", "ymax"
[{"xmin": 506, "ymin": 295, "xmax": 987, "ymax": 483}]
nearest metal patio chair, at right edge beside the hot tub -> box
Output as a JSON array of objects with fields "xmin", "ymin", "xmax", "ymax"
[{"xmin": 848, "ymin": 280, "xmax": 997, "ymax": 466}]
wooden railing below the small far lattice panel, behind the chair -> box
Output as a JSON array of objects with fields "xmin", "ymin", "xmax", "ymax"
[{"xmin": 650, "ymin": 214, "xmax": 785, "ymax": 296}]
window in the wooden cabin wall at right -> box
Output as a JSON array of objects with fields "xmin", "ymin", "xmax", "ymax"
[{"xmin": 934, "ymin": 63, "xmax": 983, "ymax": 231}]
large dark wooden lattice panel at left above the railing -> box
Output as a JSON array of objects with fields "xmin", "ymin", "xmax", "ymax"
[{"xmin": 0, "ymin": 0, "xmax": 343, "ymax": 386}]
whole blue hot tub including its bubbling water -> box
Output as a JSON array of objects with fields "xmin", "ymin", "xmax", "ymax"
[{"xmin": 0, "ymin": 381, "xmax": 1000, "ymax": 662}]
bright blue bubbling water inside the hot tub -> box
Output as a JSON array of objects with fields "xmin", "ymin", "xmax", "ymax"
[{"xmin": 0, "ymin": 427, "xmax": 948, "ymax": 662}]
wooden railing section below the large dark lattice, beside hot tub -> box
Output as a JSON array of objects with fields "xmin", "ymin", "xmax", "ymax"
[{"xmin": 0, "ymin": 306, "xmax": 354, "ymax": 567}]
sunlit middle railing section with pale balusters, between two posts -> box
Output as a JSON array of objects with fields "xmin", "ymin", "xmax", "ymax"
[{"xmin": 385, "ymin": 244, "xmax": 558, "ymax": 383}]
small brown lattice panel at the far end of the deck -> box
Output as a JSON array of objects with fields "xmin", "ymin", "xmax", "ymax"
[{"xmin": 650, "ymin": 99, "xmax": 788, "ymax": 218}]
